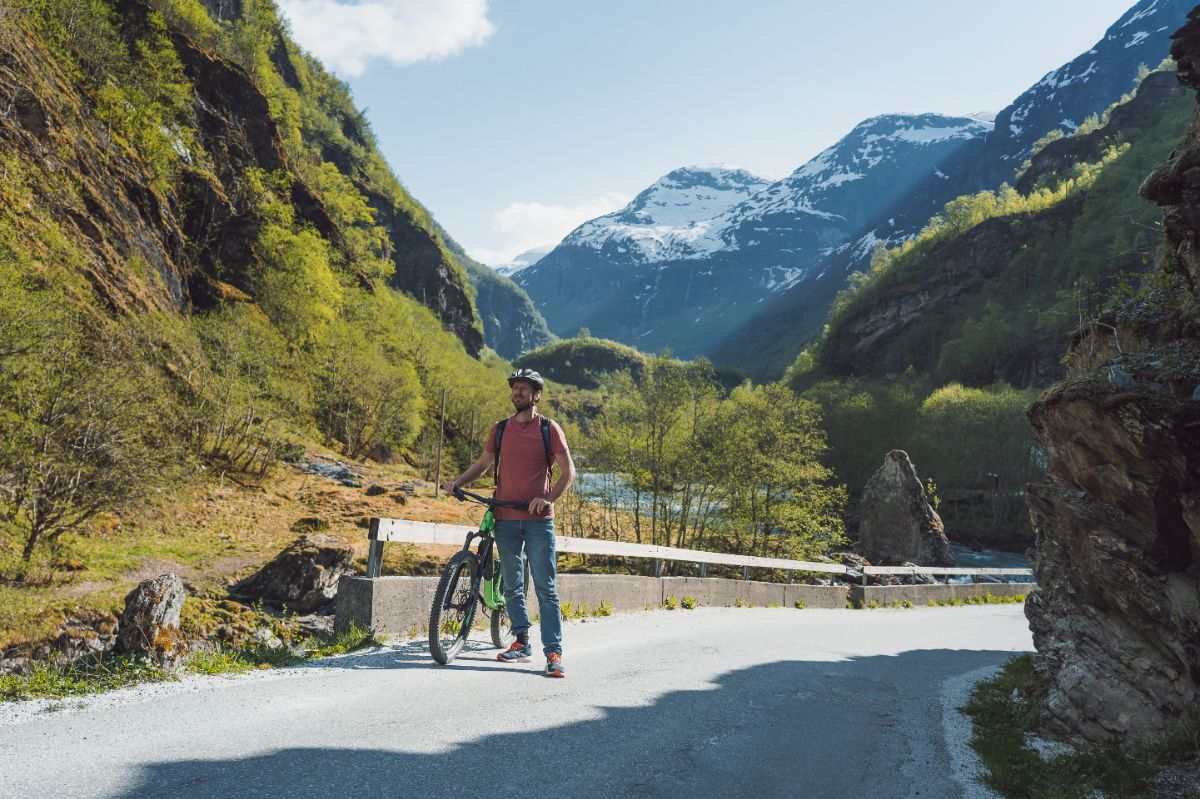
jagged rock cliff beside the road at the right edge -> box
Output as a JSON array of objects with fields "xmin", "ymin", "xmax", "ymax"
[{"xmin": 1026, "ymin": 10, "xmax": 1200, "ymax": 741}]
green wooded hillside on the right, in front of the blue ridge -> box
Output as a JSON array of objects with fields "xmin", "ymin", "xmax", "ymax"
[{"xmin": 815, "ymin": 71, "xmax": 1195, "ymax": 388}]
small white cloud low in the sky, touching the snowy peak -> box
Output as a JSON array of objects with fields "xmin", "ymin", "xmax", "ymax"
[{"xmin": 467, "ymin": 192, "xmax": 630, "ymax": 265}]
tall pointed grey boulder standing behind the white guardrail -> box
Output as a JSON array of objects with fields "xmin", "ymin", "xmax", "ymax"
[{"xmin": 858, "ymin": 450, "xmax": 954, "ymax": 566}]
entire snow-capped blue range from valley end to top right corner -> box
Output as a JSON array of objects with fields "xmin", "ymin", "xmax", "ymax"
[{"xmin": 514, "ymin": 0, "xmax": 1192, "ymax": 362}]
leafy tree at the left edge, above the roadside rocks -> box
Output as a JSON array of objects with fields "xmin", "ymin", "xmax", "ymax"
[{"xmin": 0, "ymin": 275, "xmax": 173, "ymax": 573}]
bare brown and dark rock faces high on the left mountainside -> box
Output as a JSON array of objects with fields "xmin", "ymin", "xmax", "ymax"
[{"xmin": 0, "ymin": 0, "xmax": 482, "ymax": 355}]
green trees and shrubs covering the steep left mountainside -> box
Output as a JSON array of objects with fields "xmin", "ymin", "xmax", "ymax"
[{"xmin": 0, "ymin": 0, "xmax": 520, "ymax": 577}]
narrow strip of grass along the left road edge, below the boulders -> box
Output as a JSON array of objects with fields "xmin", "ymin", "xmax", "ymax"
[{"xmin": 0, "ymin": 625, "xmax": 374, "ymax": 702}]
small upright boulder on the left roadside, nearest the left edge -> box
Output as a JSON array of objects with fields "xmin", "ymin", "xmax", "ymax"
[{"xmin": 116, "ymin": 575, "xmax": 188, "ymax": 669}]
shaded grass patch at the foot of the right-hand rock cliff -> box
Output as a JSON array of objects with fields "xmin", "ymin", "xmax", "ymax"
[{"xmin": 962, "ymin": 655, "xmax": 1200, "ymax": 799}]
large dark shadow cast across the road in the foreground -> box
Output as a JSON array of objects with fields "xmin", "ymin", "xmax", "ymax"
[{"xmin": 116, "ymin": 647, "xmax": 1013, "ymax": 799}]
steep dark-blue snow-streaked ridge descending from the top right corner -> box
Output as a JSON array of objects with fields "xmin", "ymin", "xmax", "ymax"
[{"xmin": 707, "ymin": 0, "xmax": 1193, "ymax": 378}]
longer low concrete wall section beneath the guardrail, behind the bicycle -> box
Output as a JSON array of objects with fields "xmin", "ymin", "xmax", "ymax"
[{"xmin": 334, "ymin": 575, "xmax": 848, "ymax": 637}]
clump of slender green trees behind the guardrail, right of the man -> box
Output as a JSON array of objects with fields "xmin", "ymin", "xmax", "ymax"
[{"xmin": 565, "ymin": 355, "xmax": 845, "ymax": 558}]
